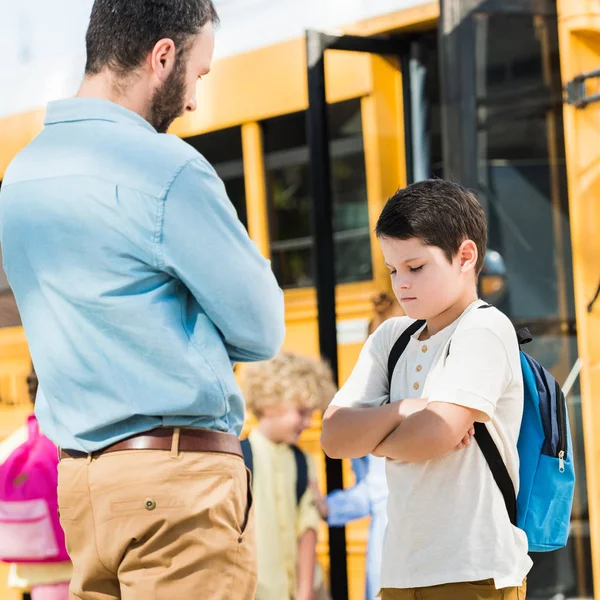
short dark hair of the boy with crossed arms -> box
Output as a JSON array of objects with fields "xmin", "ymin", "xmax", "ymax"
[{"xmin": 375, "ymin": 179, "xmax": 487, "ymax": 275}]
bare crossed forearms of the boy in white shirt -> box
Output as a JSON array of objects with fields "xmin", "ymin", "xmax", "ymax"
[{"xmin": 321, "ymin": 398, "xmax": 480, "ymax": 462}]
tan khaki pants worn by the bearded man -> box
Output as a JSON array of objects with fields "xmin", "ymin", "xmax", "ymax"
[{"xmin": 58, "ymin": 450, "xmax": 256, "ymax": 600}]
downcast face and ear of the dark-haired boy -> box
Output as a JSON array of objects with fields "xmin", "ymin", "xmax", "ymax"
[{"xmin": 379, "ymin": 238, "xmax": 477, "ymax": 319}]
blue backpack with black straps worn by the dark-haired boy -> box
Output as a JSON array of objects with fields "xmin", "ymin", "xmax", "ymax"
[{"xmin": 388, "ymin": 304, "xmax": 575, "ymax": 552}]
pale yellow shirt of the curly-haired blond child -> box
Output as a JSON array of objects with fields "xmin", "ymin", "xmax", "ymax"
[{"xmin": 249, "ymin": 429, "xmax": 321, "ymax": 600}]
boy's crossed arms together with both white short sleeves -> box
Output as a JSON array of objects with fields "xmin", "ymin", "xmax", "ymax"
[{"xmin": 321, "ymin": 321, "xmax": 510, "ymax": 462}]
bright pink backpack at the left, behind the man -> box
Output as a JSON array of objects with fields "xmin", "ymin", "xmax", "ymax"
[{"xmin": 0, "ymin": 415, "xmax": 69, "ymax": 563}]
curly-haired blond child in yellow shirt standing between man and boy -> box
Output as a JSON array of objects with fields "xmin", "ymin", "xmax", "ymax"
[{"xmin": 241, "ymin": 352, "xmax": 336, "ymax": 600}]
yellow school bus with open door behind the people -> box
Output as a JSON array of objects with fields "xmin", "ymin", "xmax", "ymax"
[{"xmin": 0, "ymin": 0, "xmax": 600, "ymax": 600}]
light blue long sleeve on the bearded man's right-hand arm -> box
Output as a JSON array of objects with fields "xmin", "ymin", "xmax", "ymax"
[{"xmin": 157, "ymin": 157, "xmax": 285, "ymax": 361}]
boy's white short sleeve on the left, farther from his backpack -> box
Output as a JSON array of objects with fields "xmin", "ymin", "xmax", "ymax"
[{"xmin": 331, "ymin": 317, "xmax": 411, "ymax": 408}]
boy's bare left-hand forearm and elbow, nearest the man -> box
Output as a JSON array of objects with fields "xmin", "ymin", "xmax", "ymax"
[{"xmin": 321, "ymin": 402, "xmax": 401, "ymax": 458}]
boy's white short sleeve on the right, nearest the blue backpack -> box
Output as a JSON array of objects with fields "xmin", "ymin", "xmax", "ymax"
[{"xmin": 427, "ymin": 328, "xmax": 513, "ymax": 419}]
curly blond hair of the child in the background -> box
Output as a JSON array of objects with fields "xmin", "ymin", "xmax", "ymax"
[{"xmin": 241, "ymin": 352, "xmax": 337, "ymax": 416}]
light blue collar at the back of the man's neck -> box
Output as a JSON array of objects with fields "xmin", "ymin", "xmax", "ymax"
[{"xmin": 44, "ymin": 98, "xmax": 156, "ymax": 133}]
